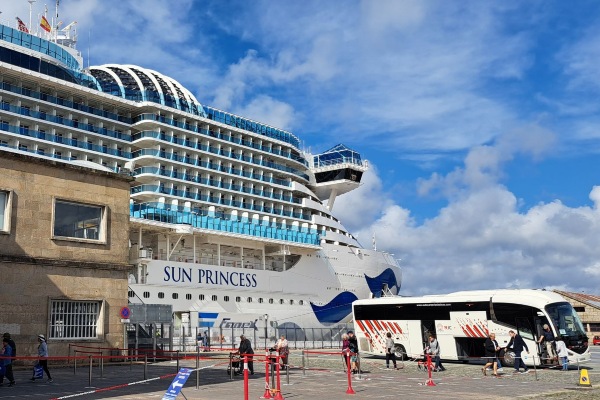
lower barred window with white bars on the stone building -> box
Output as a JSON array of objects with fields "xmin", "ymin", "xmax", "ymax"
[{"xmin": 49, "ymin": 300, "xmax": 104, "ymax": 340}]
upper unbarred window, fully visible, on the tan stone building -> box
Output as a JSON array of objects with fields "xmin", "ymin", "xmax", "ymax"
[{"xmin": 52, "ymin": 200, "xmax": 106, "ymax": 241}]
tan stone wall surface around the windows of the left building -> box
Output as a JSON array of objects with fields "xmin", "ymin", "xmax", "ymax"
[{"xmin": 0, "ymin": 150, "xmax": 131, "ymax": 356}]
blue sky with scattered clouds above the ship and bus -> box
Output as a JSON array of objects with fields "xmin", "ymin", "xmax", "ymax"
[{"xmin": 0, "ymin": 0, "xmax": 600, "ymax": 295}]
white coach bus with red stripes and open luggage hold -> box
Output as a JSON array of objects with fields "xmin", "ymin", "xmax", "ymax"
[{"xmin": 352, "ymin": 290, "xmax": 591, "ymax": 366}]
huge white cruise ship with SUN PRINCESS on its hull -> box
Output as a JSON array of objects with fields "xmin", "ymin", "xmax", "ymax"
[{"xmin": 0, "ymin": 21, "xmax": 401, "ymax": 338}]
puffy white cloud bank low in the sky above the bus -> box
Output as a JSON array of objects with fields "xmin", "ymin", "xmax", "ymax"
[{"xmin": 336, "ymin": 127, "xmax": 600, "ymax": 294}]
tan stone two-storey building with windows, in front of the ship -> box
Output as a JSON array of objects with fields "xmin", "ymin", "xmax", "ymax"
[{"xmin": 0, "ymin": 147, "xmax": 132, "ymax": 356}]
